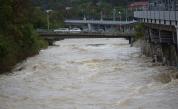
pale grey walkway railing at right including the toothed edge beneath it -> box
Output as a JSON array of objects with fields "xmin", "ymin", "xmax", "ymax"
[{"xmin": 134, "ymin": 11, "xmax": 178, "ymax": 25}]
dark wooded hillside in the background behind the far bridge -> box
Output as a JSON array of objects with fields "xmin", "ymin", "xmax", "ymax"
[{"xmin": 33, "ymin": 0, "xmax": 138, "ymax": 21}]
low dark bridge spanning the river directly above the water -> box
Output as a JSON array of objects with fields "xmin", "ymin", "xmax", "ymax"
[{"xmin": 39, "ymin": 32, "xmax": 134, "ymax": 45}]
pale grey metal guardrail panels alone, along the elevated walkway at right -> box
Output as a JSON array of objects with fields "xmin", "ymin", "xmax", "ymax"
[{"xmin": 134, "ymin": 11, "xmax": 178, "ymax": 21}]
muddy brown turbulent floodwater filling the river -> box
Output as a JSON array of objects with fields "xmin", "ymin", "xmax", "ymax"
[{"xmin": 0, "ymin": 39, "xmax": 178, "ymax": 109}]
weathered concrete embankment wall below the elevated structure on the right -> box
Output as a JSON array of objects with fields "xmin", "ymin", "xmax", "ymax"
[{"xmin": 141, "ymin": 40, "xmax": 178, "ymax": 66}]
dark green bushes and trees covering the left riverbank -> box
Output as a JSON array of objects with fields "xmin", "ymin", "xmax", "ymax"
[{"xmin": 0, "ymin": 0, "xmax": 48, "ymax": 73}]
